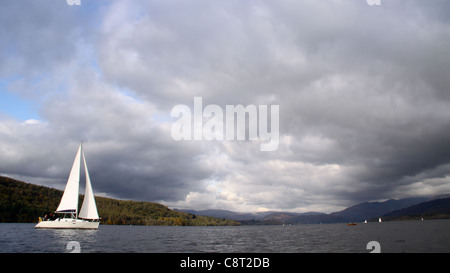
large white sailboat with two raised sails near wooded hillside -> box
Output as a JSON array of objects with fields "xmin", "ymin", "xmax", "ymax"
[{"xmin": 35, "ymin": 144, "xmax": 100, "ymax": 229}]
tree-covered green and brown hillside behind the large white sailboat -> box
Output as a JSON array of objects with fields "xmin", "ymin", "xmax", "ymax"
[{"xmin": 0, "ymin": 176, "xmax": 239, "ymax": 226}]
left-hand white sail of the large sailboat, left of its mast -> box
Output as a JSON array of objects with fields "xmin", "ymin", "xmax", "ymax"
[{"xmin": 56, "ymin": 145, "xmax": 81, "ymax": 214}]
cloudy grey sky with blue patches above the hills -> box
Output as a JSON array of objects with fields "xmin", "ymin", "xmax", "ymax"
[{"xmin": 0, "ymin": 0, "xmax": 450, "ymax": 213}]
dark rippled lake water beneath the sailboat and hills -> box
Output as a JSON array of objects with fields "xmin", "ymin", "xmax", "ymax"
[{"xmin": 0, "ymin": 220, "xmax": 450, "ymax": 253}]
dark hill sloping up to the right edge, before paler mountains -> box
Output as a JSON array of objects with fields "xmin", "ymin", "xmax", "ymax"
[{"xmin": 383, "ymin": 197, "xmax": 450, "ymax": 220}]
